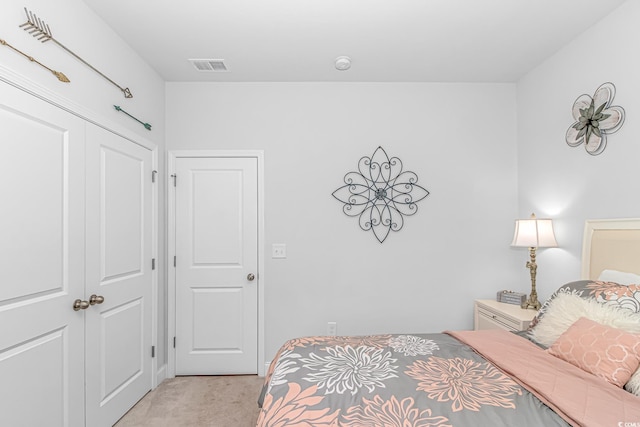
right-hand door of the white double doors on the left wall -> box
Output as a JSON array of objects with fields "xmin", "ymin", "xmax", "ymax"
[{"xmin": 85, "ymin": 124, "xmax": 152, "ymax": 427}]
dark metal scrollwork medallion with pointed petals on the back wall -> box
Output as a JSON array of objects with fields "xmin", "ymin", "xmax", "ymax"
[{"xmin": 332, "ymin": 147, "xmax": 429, "ymax": 243}]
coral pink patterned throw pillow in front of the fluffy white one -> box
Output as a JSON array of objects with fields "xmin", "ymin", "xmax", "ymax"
[{"xmin": 547, "ymin": 317, "xmax": 640, "ymax": 387}]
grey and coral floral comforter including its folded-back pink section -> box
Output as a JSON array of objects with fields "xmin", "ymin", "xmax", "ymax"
[{"xmin": 258, "ymin": 283, "xmax": 640, "ymax": 427}]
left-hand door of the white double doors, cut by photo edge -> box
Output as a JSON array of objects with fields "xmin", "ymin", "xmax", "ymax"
[{"xmin": 0, "ymin": 82, "xmax": 86, "ymax": 427}]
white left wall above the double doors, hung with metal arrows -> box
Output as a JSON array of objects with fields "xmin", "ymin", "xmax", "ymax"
[{"xmin": 0, "ymin": 0, "xmax": 166, "ymax": 367}]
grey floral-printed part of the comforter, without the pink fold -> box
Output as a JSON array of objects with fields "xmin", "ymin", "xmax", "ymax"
[{"xmin": 258, "ymin": 334, "xmax": 568, "ymax": 427}]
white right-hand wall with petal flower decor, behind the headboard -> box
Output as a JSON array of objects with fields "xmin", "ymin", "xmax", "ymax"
[{"xmin": 517, "ymin": 0, "xmax": 640, "ymax": 298}]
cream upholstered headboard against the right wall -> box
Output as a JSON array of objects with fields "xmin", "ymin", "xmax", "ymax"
[{"xmin": 581, "ymin": 218, "xmax": 640, "ymax": 280}]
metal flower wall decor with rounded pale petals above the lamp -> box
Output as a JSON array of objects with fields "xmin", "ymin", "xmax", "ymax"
[{"xmin": 565, "ymin": 82, "xmax": 624, "ymax": 156}]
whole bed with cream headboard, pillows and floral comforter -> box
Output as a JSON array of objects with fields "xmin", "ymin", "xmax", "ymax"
[{"xmin": 257, "ymin": 219, "xmax": 640, "ymax": 427}]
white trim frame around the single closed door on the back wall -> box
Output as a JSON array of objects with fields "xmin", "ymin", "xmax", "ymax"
[{"xmin": 165, "ymin": 150, "xmax": 266, "ymax": 378}]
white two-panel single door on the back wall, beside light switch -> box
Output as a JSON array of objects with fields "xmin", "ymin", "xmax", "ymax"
[{"xmin": 175, "ymin": 157, "xmax": 259, "ymax": 375}]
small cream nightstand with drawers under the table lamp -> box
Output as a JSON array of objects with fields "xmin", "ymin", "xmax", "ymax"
[{"xmin": 473, "ymin": 299, "xmax": 537, "ymax": 332}]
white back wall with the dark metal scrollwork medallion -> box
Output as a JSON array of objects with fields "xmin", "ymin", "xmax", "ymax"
[{"xmin": 166, "ymin": 83, "xmax": 528, "ymax": 360}]
